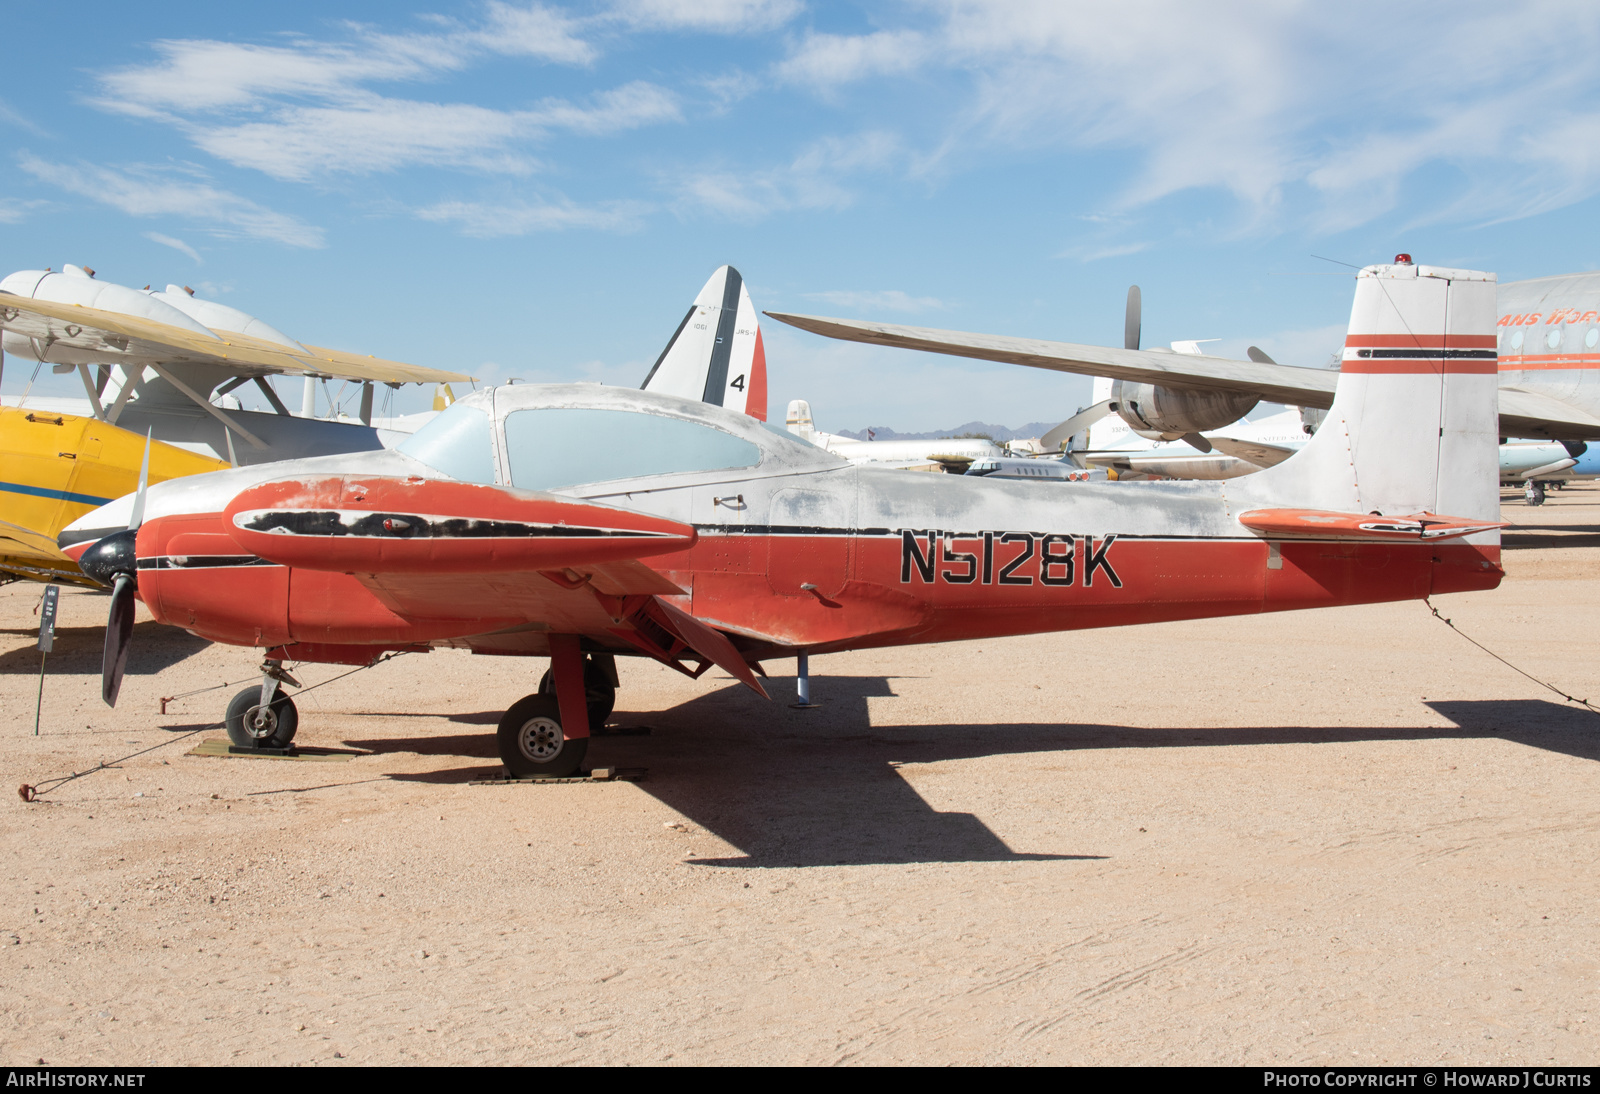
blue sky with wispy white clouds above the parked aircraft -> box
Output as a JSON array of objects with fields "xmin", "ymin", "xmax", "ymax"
[{"xmin": 0, "ymin": 0, "xmax": 1600, "ymax": 430}]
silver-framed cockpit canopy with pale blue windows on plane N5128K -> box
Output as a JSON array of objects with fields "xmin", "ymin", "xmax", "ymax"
[{"xmin": 400, "ymin": 384, "xmax": 845, "ymax": 497}]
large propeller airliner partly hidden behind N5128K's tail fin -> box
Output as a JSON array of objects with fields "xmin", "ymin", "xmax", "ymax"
[{"xmin": 766, "ymin": 254, "xmax": 1600, "ymax": 451}]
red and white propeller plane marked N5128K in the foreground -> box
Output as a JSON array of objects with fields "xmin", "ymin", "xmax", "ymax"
[{"xmin": 62, "ymin": 266, "xmax": 1502, "ymax": 774}]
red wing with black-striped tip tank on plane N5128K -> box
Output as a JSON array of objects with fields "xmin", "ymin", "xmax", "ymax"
[{"xmin": 224, "ymin": 475, "xmax": 765, "ymax": 694}]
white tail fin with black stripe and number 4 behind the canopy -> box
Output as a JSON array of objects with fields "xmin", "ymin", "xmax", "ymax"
[{"xmin": 643, "ymin": 266, "xmax": 766, "ymax": 422}]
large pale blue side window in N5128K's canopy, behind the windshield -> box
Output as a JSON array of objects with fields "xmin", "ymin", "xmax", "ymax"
[{"xmin": 506, "ymin": 408, "xmax": 762, "ymax": 489}]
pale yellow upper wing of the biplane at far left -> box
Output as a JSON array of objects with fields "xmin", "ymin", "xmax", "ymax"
[{"xmin": 0, "ymin": 293, "xmax": 472, "ymax": 384}]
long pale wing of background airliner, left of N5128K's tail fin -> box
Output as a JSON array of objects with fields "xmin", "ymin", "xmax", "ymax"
[{"xmin": 766, "ymin": 312, "xmax": 1339, "ymax": 409}]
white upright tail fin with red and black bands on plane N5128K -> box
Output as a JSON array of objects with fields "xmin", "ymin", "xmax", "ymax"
[{"xmin": 1240, "ymin": 262, "xmax": 1499, "ymax": 524}]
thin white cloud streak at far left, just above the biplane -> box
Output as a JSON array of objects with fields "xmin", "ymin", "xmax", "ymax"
[{"xmin": 21, "ymin": 154, "xmax": 325, "ymax": 248}]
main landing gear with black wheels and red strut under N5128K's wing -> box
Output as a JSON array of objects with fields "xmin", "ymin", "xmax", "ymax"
[{"xmin": 496, "ymin": 646, "xmax": 616, "ymax": 779}]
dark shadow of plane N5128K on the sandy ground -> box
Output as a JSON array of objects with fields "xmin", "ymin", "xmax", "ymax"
[{"xmin": 331, "ymin": 677, "xmax": 1600, "ymax": 867}]
